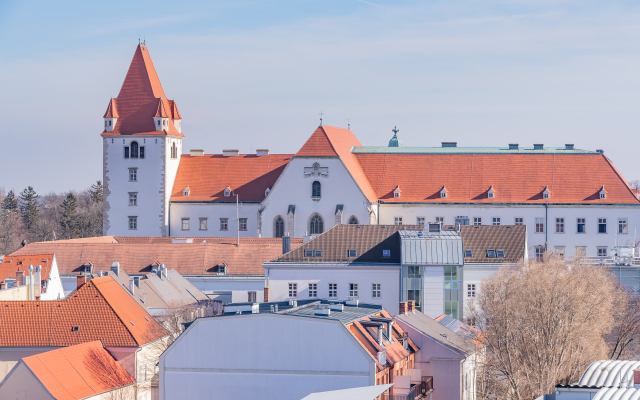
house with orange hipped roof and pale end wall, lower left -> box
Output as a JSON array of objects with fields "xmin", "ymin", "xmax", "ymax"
[{"xmin": 0, "ymin": 275, "xmax": 169, "ymax": 399}]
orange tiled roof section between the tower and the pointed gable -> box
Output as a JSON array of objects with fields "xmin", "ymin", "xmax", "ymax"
[{"xmin": 171, "ymin": 154, "xmax": 291, "ymax": 203}]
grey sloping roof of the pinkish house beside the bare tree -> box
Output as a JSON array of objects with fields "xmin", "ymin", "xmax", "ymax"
[{"xmin": 395, "ymin": 311, "xmax": 476, "ymax": 357}]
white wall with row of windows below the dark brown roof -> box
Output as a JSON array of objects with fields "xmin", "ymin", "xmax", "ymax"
[{"xmin": 265, "ymin": 264, "xmax": 400, "ymax": 314}]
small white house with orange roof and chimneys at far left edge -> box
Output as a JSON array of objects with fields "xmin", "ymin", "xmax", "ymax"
[{"xmin": 0, "ymin": 253, "xmax": 64, "ymax": 300}]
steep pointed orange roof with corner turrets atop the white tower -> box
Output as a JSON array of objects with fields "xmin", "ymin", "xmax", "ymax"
[{"xmin": 102, "ymin": 44, "xmax": 184, "ymax": 137}]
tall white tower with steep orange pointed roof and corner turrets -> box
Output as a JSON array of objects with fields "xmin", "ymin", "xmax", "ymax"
[{"xmin": 101, "ymin": 43, "xmax": 184, "ymax": 236}]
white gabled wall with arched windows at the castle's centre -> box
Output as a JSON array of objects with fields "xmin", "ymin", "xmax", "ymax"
[{"xmin": 262, "ymin": 158, "xmax": 369, "ymax": 237}]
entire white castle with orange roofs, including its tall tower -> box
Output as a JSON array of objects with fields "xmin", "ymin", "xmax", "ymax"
[{"xmin": 101, "ymin": 44, "xmax": 640, "ymax": 257}]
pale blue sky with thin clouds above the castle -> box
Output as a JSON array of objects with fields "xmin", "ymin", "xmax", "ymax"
[{"xmin": 0, "ymin": 0, "xmax": 640, "ymax": 194}]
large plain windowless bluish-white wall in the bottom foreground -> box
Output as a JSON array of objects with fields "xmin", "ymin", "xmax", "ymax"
[{"xmin": 160, "ymin": 314, "xmax": 375, "ymax": 400}]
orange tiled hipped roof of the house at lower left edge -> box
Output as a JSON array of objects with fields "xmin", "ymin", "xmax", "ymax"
[{"xmin": 0, "ymin": 276, "xmax": 168, "ymax": 347}]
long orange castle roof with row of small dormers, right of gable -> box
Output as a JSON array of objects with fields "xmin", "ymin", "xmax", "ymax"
[{"xmin": 355, "ymin": 154, "xmax": 640, "ymax": 204}]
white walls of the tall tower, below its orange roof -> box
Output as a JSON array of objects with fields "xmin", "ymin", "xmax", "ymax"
[{"xmin": 102, "ymin": 135, "xmax": 182, "ymax": 236}]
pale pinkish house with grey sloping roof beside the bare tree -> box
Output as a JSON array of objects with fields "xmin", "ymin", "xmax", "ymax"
[{"xmin": 394, "ymin": 302, "xmax": 484, "ymax": 400}]
